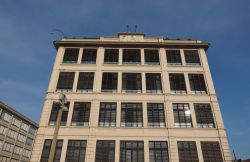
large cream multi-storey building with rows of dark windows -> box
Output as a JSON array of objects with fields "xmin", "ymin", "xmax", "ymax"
[{"xmin": 31, "ymin": 33, "xmax": 231, "ymax": 162}]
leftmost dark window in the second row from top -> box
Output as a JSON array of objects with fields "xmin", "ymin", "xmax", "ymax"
[{"xmin": 57, "ymin": 72, "xmax": 75, "ymax": 91}]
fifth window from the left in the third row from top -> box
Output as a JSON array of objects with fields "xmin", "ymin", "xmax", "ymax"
[{"xmin": 147, "ymin": 103, "xmax": 166, "ymax": 127}]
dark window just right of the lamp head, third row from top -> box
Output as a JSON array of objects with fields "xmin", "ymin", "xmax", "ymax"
[{"xmin": 72, "ymin": 102, "xmax": 91, "ymax": 126}]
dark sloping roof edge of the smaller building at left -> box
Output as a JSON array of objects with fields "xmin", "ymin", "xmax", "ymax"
[{"xmin": 0, "ymin": 101, "xmax": 38, "ymax": 128}]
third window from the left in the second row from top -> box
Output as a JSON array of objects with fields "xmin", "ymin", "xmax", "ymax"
[{"xmin": 102, "ymin": 73, "xmax": 118, "ymax": 92}]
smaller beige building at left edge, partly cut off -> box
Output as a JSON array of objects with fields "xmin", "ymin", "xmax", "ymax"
[{"xmin": 0, "ymin": 102, "xmax": 38, "ymax": 162}]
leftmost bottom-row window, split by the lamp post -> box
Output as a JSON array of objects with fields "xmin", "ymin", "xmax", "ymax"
[{"xmin": 40, "ymin": 139, "xmax": 63, "ymax": 162}]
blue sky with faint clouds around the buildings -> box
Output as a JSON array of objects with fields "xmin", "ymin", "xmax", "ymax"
[{"xmin": 0, "ymin": 0, "xmax": 250, "ymax": 159}]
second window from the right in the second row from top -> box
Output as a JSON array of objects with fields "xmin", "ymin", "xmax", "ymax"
[{"xmin": 169, "ymin": 73, "xmax": 187, "ymax": 94}]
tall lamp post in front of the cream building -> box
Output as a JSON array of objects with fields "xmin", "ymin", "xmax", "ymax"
[{"xmin": 48, "ymin": 93, "xmax": 68, "ymax": 162}]
